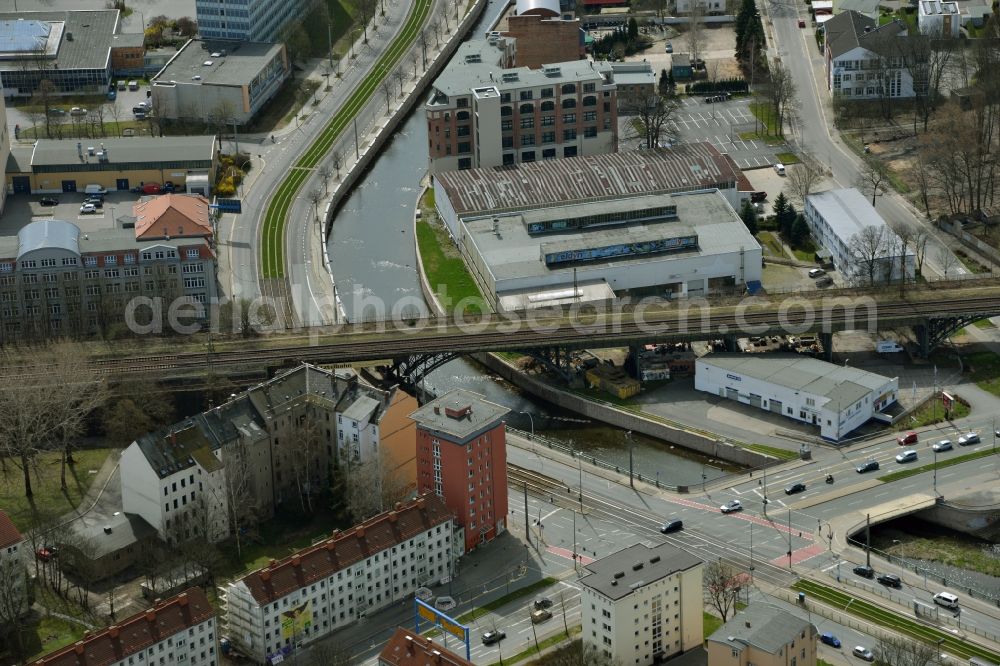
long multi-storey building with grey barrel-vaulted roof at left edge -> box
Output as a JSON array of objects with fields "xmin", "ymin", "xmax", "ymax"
[{"xmin": 0, "ymin": 219, "xmax": 217, "ymax": 341}]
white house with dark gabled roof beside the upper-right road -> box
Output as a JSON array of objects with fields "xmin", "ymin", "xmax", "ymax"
[{"xmin": 823, "ymin": 11, "xmax": 914, "ymax": 100}]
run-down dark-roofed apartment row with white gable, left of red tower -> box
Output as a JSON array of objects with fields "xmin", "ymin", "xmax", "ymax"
[{"xmin": 121, "ymin": 364, "xmax": 414, "ymax": 543}]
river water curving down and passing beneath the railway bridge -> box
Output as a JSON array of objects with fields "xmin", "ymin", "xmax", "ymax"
[{"xmin": 328, "ymin": 0, "xmax": 725, "ymax": 485}]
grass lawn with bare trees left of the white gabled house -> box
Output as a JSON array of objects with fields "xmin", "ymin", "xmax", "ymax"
[{"xmin": 0, "ymin": 449, "xmax": 111, "ymax": 532}]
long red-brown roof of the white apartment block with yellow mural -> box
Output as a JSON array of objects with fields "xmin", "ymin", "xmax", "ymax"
[{"xmin": 242, "ymin": 493, "xmax": 454, "ymax": 606}]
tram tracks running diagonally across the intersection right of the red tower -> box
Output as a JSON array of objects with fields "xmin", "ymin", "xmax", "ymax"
[{"xmin": 507, "ymin": 463, "xmax": 798, "ymax": 587}]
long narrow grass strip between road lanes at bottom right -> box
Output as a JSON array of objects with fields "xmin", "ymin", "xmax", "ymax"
[{"xmin": 792, "ymin": 580, "xmax": 1000, "ymax": 663}]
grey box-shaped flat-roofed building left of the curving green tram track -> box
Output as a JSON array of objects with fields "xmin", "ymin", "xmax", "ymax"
[{"xmin": 150, "ymin": 39, "xmax": 292, "ymax": 125}]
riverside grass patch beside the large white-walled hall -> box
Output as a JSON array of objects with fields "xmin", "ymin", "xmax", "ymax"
[{"xmin": 417, "ymin": 220, "xmax": 489, "ymax": 314}]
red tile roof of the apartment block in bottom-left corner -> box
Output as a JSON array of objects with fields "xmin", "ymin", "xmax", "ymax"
[{"xmin": 33, "ymin": 587, "xmax": 218, "ymax": 666}]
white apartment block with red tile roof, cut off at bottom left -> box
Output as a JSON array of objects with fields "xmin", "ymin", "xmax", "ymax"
[{"xmin": 32, "ymin": 587, "xmax": 219, "ymax": 666}]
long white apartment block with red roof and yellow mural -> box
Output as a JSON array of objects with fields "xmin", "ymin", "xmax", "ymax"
[{"xmin": 225, "ymin": 494, "xmax": 462, "ymax": 663}]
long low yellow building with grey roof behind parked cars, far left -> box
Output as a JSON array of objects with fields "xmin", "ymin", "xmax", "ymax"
[{"xmin": 7, "ymin": 135, "xmax": 218, "ymax": 196}]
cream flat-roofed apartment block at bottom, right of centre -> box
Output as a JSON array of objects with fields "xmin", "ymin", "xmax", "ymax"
[{"xmin": 580, "ymin": 543, "xmax": 704, "ymax": 666}]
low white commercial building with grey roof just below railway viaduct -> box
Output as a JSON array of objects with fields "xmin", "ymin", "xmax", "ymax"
[{"xmin": 694, "ymin": 354, "xmax": 899, "ymax": 441}]
